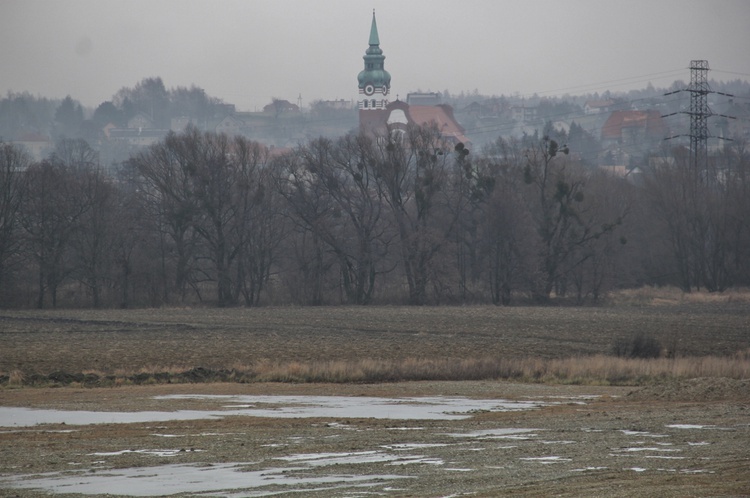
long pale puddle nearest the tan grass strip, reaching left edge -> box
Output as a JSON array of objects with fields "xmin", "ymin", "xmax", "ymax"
[{"xmin": 0, "ymin": 395, "xmax": 546, "ymax": 427}]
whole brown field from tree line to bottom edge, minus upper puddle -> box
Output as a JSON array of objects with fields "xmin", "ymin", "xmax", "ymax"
[{"xmin": 0, "ymin": 290, "xmax": 750, "ymax": 498}]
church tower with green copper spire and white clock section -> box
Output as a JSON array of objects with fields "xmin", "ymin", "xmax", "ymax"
[{"xmin": 357, "ymin": 10, "xmax": 391, "ymax": 111}]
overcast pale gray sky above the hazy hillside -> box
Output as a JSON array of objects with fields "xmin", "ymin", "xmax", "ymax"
[{"xmin": 0, "ymin": 0, "xmax": 750, "ymax": 110}]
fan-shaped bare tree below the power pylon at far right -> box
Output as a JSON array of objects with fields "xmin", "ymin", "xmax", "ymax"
[{"xmin": 646, "ymin": 141, "xmax": 748, "ymax": 292}]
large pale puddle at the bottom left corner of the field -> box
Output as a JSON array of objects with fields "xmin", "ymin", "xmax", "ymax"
[{"xmin": 0, "ymin": 463, "xmax": 408, "ymax": 496}]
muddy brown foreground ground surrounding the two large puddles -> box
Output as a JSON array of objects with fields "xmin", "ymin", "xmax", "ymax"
[{"xmin": 0, "ymin": 379, "xmax": 750, "ymax": 497}]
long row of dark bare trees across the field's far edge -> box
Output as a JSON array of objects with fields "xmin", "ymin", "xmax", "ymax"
[{"xmin": 0, "ymin": 126, "xmax": 750, "ymax": 308}]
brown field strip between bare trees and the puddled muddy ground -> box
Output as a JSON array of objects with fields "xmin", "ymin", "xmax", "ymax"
[{"xmin": 0, "ymin": 288, "xmax": 750, "ymax": 387}]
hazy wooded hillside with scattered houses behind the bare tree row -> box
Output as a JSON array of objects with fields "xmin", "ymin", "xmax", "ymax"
[{"xmin": 0, "ymin": 21, "xmax": 750, "ymax": 175}]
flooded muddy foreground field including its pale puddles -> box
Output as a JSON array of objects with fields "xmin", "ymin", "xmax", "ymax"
[{"xmin": 0, "ymin": 382, "xmax": 750, "ymax": 498}]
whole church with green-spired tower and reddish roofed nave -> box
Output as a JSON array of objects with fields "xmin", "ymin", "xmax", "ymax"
[{"xmin": 357, "ymin": 11, "xmax": 470, "ymax": 145}]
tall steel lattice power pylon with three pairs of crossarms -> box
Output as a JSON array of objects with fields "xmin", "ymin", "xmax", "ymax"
[{"xmin": 662, "ymin": 60, "xmax": 734, "ymax": 171}]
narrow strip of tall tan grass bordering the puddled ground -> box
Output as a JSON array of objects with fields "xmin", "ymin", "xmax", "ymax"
[{"xmin": 5, "ymin": 351, "xmax": 750, "ymax": 388}]
